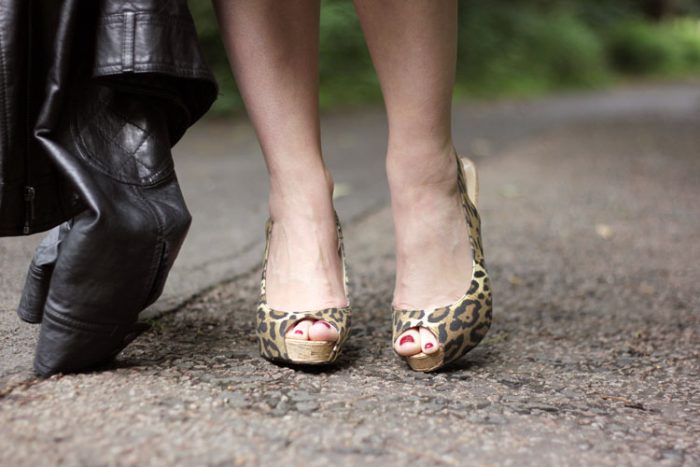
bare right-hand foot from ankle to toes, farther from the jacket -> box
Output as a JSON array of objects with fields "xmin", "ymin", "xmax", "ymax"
[{"xmin": 387, "ymin": 146, "xmax": 472, "ymax": 356}]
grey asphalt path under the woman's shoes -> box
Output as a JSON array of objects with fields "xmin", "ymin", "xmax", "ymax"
[{"xmin": 0, "ymin": 82, "xmax": 700, "ymax": 467}]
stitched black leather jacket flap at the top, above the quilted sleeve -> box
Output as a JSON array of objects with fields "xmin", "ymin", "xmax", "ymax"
[{"xmin": 92, "ymin": 5, "xmax": 218, "ymax": 144}]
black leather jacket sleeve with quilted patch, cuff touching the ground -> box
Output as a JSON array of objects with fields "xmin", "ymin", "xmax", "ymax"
[{"xmin": 18, "ymin": 85, "xmax": 191, "ymax": 375}]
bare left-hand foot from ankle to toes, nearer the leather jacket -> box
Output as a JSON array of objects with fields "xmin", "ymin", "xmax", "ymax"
[{"xmin": 266, "ymin": 166, "xmax": 347, "ymax": 341}]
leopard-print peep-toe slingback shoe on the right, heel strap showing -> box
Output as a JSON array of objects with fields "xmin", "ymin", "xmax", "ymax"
[{"xmin": 392, "ymin": 157, "xmax": 492, "ymax": 371}]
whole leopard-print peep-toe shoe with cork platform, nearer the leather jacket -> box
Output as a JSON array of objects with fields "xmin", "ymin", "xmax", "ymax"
[{"xmin": 256, "ymin": 213, "xmax": 352, "ymax": 365}]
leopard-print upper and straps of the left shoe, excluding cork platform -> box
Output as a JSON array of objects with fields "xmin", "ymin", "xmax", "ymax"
[{"xmin": 256, "ymin": 214, "xmax": 352, "ymax": 363}]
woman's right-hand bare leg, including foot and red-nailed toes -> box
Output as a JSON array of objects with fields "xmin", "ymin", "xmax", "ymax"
[{"xmin": 354, "ymin": 0, "xmax": 472, "ymax": 355}]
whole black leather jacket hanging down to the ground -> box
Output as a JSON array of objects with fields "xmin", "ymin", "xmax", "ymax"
[{"xmin": 0, "ymin": 0, "xmax": 217, "ymax": 375}]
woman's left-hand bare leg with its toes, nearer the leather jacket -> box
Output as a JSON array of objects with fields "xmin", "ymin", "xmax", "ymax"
[{"xmin": 214, "ymin": 0, "xmax": 346, "ymax": 340}]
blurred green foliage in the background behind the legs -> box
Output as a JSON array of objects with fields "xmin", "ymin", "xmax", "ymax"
[{"xmin": 190, "ymin": 0, "xmax": 700, "ymax": 115}]
